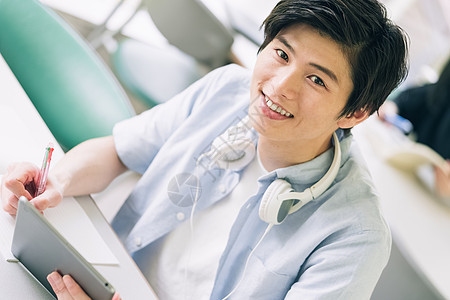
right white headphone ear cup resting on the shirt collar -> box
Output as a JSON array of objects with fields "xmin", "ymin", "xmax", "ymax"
[{"xmin": 259, "ymin": 179, "xmax": 294, "ymax": 224}]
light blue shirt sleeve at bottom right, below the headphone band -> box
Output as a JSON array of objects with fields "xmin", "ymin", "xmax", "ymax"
[{"xmin": 285, "ymin": 230, "xmax": 391, "ymax": 300}]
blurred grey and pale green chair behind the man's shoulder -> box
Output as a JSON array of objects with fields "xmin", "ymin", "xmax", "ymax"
[{"xmin": 89, "ymin": 0, "xmax": 234, "ymax": 107}]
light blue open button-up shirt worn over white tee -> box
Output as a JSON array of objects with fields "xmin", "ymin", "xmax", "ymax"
[{"xmin": 112, "ymin": 65, "xmax": 391, "ymax": 300}]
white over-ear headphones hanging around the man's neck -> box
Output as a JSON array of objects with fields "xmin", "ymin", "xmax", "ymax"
[{"xmin": 202, "ymin": 116, "xmax": 341, "ymax": 224}]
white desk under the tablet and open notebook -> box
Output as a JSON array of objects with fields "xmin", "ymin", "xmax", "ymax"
[{"xmin": 0, "ymin": 55, "xmax": 156, "ymax": 300}]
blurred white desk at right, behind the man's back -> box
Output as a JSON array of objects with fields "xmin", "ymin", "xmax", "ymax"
[{"xmin": 353, "ymin": 117, "xmax": 450, "ymax": 299}]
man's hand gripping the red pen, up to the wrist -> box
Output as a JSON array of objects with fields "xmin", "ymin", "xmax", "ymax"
[{"xmin": 0, "ymin": 162, "xmax": 62, "ymax": 215}]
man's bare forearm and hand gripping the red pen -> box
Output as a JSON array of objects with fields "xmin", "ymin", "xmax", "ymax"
[{"xmin": 1, "ymin": 136, "xmax": 126, "ymax": 215}]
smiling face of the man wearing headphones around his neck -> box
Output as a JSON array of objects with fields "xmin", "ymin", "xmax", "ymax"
[{"xmin": 249, "ymin": 24, "xmax": 354, "ymax": 158}]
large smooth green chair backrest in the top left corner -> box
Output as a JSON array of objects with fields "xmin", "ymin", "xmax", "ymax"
[{"xmin": 0, "ymin": 0, "xmax": 135, "ymax": 151}]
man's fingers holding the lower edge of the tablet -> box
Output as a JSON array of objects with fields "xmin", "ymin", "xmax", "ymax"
[{"xmin": 47, "ymin": 272, "xmax": 120, "ymax": 300}]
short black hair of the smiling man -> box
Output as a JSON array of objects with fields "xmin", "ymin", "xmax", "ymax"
[{"xmin": 258, "ymin": 0, "xmax": 408, "ymax": 117}]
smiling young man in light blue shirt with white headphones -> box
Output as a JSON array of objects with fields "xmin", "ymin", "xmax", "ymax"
[{"xmin": 2, "ymin": 0, "xmax": 407, "ymax": 299}]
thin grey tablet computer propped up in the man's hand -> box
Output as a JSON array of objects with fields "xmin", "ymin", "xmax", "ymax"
[{"xmin": 11, "ymin": 197, "xmax": 114, "ymax": 300}]
